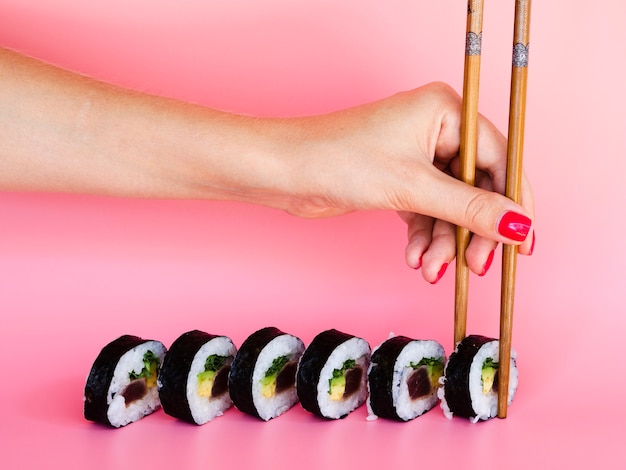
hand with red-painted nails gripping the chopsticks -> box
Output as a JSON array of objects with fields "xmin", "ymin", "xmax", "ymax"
[{"xmin": 280, "ymin": 83, "xmax": 534, "ymax": 283}]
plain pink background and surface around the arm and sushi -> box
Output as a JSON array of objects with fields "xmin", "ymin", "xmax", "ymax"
[{"xmin": 0, "ymin": 0, "xmax": 626, "ymax": 469}]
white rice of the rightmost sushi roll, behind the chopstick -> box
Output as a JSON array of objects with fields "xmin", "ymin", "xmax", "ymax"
[{"xmin": 438, "ymin": 340, "xmax": 518, "ymax": 423}]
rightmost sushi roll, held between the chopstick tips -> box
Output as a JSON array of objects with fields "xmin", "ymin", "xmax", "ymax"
[{"xmin": 438, "ymin": 335, "xmax": 518, "ymax": 423}]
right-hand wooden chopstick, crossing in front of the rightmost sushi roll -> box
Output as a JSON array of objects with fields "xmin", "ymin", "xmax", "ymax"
[{"xmin": 498, "ymin": 0, "xmax": 531, "ymax": 418}]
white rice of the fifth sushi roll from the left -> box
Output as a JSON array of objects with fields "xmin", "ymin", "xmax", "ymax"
[{"xmin": 367, "ymin": 340, "xmax": 446, "ymax": 421}]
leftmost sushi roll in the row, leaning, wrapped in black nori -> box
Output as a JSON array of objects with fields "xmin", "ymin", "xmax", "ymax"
[{"xmin": 84, "ymin": 335, "xmax": 166, "ymax": 428}]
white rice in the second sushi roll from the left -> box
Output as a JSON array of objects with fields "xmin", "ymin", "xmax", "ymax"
[{"xmin": 187, "ymin": 336, "xmax": 237, "ymax": 424}]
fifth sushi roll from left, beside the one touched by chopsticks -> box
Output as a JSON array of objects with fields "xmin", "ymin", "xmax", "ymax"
[{"xmin": 367, "ymin": 336, "xmax": 446, "ymax": 421}]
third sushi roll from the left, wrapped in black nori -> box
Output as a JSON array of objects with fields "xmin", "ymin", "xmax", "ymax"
[{"xmin": 228, "ymin": 327, "xmax": 304, "ymax": 421}]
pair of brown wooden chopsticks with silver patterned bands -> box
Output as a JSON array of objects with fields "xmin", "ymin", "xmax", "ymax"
[{"xmin": 454, "ymin": 0, "xmax": 531, "ymax": 418}]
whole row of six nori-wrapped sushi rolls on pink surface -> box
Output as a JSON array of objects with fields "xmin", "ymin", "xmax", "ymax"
[{"xmin": 84, "ymin": 327, "xmax": 518, "ymax": 428}]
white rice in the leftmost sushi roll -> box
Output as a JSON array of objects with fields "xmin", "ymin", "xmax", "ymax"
[{"xmin": 107, "ymin": 341, "xmax": 166, "ymax": 427}]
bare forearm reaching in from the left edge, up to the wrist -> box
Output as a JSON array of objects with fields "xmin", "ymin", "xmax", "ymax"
[{"xmin": 0, "ymin": 49, "xmax": 302, "ymax": 209}]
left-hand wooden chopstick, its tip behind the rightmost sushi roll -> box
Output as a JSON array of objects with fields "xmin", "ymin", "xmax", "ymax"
[{"xmin": 454, "ymin": 0, "xmax": 483, "ymax": 346}]
